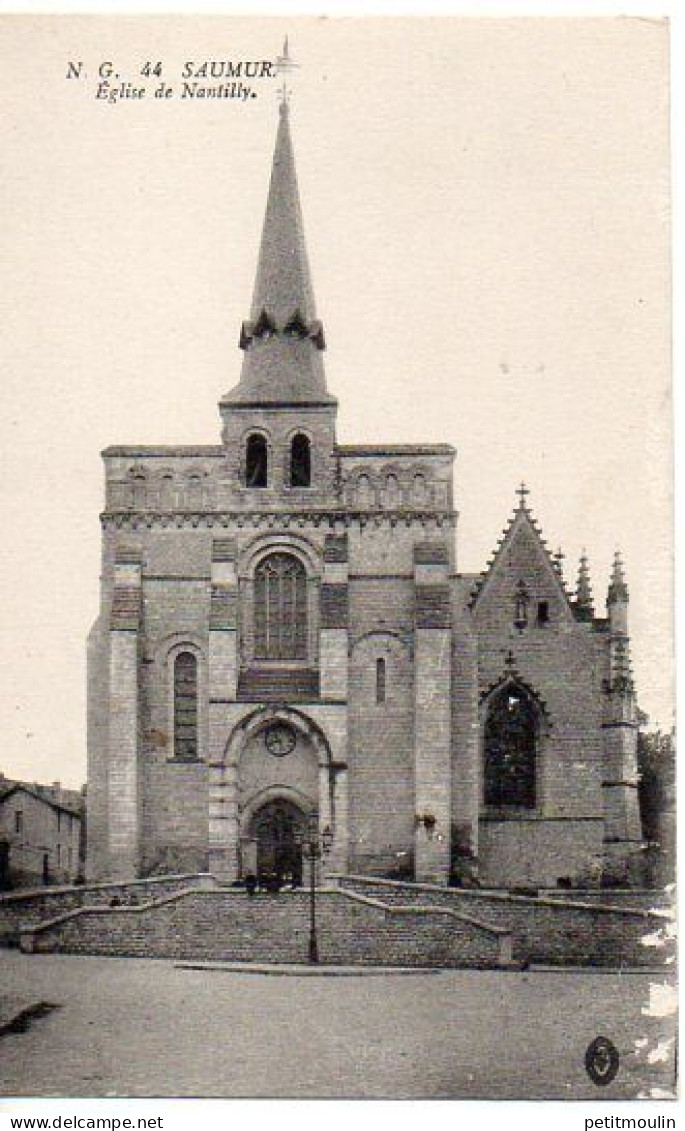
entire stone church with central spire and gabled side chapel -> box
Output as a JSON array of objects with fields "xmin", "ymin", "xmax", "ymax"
[{"xmin": 88, "ymin": 102, "xmax": 641, "ymax": 887}]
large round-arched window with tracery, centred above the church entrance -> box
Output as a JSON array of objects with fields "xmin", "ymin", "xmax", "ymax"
[{"xmin": 254, "ymin": 553, "xmax": 306, "ymax": 659}]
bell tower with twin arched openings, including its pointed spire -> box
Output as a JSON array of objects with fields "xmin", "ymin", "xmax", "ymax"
[{"xmin": 219, "ymin": 90, "xmax": 337, "ymax": 508}]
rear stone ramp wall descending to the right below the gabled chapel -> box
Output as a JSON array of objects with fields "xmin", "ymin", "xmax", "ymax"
[{"xmin": 340, "ymin": 877, "xmax": 673, "ymax": 967}]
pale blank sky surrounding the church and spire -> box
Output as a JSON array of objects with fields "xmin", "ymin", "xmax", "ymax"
[{"xmin": 0, "ymin": 16, "xmax": 674, "ymax": 785}]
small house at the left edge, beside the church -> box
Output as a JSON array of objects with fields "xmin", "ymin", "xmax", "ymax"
[{"xmin": 0, "ymin": 775, "xmax": 85, "ymax": 890}]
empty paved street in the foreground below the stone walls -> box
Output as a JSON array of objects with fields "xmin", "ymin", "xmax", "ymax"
[{"xmin": 0, "ymin": 951, "xmax": 673, "ymax": 1099}]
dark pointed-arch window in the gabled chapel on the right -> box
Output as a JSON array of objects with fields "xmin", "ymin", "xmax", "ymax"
[{"xmin": 484, "ymin": 683, "xmax": 539, "ymax": 809}]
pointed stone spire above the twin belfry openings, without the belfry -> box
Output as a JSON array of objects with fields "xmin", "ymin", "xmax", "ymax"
[{"xmin": 222, "ymin": 92, "xmax": 336, "ymax": 405}]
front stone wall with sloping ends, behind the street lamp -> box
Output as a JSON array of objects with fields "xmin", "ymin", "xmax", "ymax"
[{"xmin": 21, "ymin": 890, "xmax": 509, "ymax": 968}]
